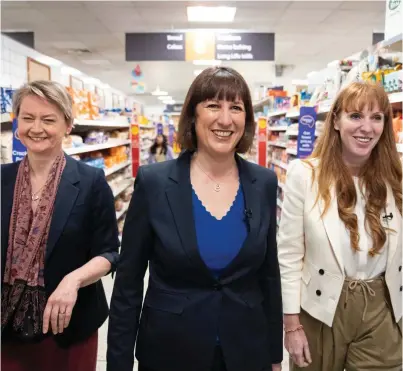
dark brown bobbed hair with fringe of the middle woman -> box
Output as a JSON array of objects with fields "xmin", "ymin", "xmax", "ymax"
[{"xmin": 178, "ymin": 67, "xmax": 256, "ymax": 153}]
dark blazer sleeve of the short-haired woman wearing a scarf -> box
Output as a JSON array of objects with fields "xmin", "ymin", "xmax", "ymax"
[{"xmin": 91, "ymin": 170, "xmax": 120, "ymax": 272}]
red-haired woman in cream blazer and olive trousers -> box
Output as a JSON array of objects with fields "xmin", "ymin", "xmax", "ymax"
[{"xmin": 278, "ymin": 83, "xmax": 402, "ymax": 371}]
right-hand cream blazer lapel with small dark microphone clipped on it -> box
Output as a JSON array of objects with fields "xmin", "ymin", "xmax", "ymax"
[{"xmin": 381, "ymin": 186, "xmax": 402, "ymax": 267}]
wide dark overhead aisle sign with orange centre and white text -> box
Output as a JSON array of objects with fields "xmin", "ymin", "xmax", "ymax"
[{"xmin": 126, "ymin": 31, "xmax": 275, "ymax": 62}]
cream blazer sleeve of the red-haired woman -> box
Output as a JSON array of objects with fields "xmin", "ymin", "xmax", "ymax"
[{"xmin": 278, "ymin": 160, "xmax": 310, "ymax": 314}]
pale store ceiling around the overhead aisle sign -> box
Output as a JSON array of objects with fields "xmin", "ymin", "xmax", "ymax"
[{"xmin": 1, "ymin": 0, "xmax": 386, "ymax": 104}]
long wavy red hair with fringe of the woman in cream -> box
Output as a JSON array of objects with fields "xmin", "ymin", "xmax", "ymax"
[{"xmin": 306, "ymin": 82, "xmax": 402, "ymax": 256}]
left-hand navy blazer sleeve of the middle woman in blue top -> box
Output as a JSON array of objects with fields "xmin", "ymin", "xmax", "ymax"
[{"xmin": 107, "ymin": 168, "xmax": 153, "ymax": 371}]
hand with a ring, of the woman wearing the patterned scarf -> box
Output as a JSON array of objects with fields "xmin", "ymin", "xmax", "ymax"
[{"xmin": 43, "ymin": 275, "xmax": 80, "ymax": 335}]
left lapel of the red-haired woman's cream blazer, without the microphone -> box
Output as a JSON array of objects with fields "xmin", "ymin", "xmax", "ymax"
[{"xmin": 318, "ymin": 187, "xmax": 344, "ymax": 272}]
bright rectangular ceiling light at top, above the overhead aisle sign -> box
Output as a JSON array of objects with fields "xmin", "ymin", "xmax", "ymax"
[{"xmin": 187, "ymin": 6, "xmax": 236, "ymax": 22}]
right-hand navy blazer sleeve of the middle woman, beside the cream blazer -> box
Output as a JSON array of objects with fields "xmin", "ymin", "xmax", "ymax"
[{"xmin": 260, "ymin": 174, "xmax": 283, "ymax": 364}]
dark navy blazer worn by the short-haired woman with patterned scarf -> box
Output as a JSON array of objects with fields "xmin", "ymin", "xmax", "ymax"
[{"xmin": 1, "ymin": 156, "xmax": 119, "ymax": 346}]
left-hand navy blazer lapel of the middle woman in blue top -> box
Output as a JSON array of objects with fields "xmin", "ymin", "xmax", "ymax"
[{"xmin": 166, "ymin": 152, "xmax": 213, "ymax": 279}]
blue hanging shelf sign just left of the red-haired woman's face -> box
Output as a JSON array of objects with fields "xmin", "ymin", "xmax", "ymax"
[{"xmin": 297, "ymin": 107, "xmax": 316, "ymax": 158}]
